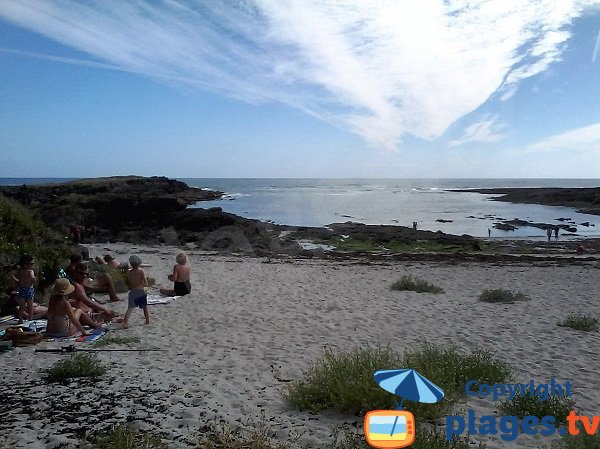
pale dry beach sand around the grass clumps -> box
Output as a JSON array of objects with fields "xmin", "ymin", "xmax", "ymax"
[{"xmin": 0, "ymin": 244, "xmax": 600, "ymax": 449}]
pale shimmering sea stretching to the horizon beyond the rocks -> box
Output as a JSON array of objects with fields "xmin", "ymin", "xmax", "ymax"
[{"xmin": 0, "ymin": 178, "xmax": 600, "ymax": 240}]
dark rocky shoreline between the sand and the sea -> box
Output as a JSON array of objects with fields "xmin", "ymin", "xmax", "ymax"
[{"xmin": 0, "ymin": 176, "xmax": 600, "ymax": 259}]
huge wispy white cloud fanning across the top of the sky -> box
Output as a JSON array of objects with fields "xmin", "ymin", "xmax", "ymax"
[{"xmin": 0, "ymin": 0, "xmax": 596, "ymax": 149}]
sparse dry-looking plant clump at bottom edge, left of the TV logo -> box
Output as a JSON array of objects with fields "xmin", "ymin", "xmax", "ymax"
[{"xmin": 196, "ymin": 418, "xmax": 293, "ymax": 449}]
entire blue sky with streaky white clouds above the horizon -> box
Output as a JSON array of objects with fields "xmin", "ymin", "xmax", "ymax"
[{"xmin": 0, "ymin": 0, "xmax": 600, "ymax": 178}]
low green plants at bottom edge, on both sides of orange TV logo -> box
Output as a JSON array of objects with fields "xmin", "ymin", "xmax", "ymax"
[{"xmin": 328, "ymin": 426, "xmax": 486, "ymax": 449}]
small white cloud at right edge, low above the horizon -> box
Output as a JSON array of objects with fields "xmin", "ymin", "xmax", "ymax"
[{"xmin": 515, "ymin": 123, "xmax": 600, "ymax": 154}]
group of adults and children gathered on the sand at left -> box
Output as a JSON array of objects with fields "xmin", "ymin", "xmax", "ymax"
[{"xmin": 14, "ymin": 253, "xmax": 191, "ymax": 337}]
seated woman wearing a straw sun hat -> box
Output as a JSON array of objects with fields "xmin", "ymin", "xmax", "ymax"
[{"xmin": 46, "ymin": 279, "xmax": 102, "ymax": 337}]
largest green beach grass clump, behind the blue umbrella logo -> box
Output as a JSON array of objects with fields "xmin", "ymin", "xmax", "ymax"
[{"xmin": 286, "ymin": 342, "xmax": 512, "ymax": 421}]
